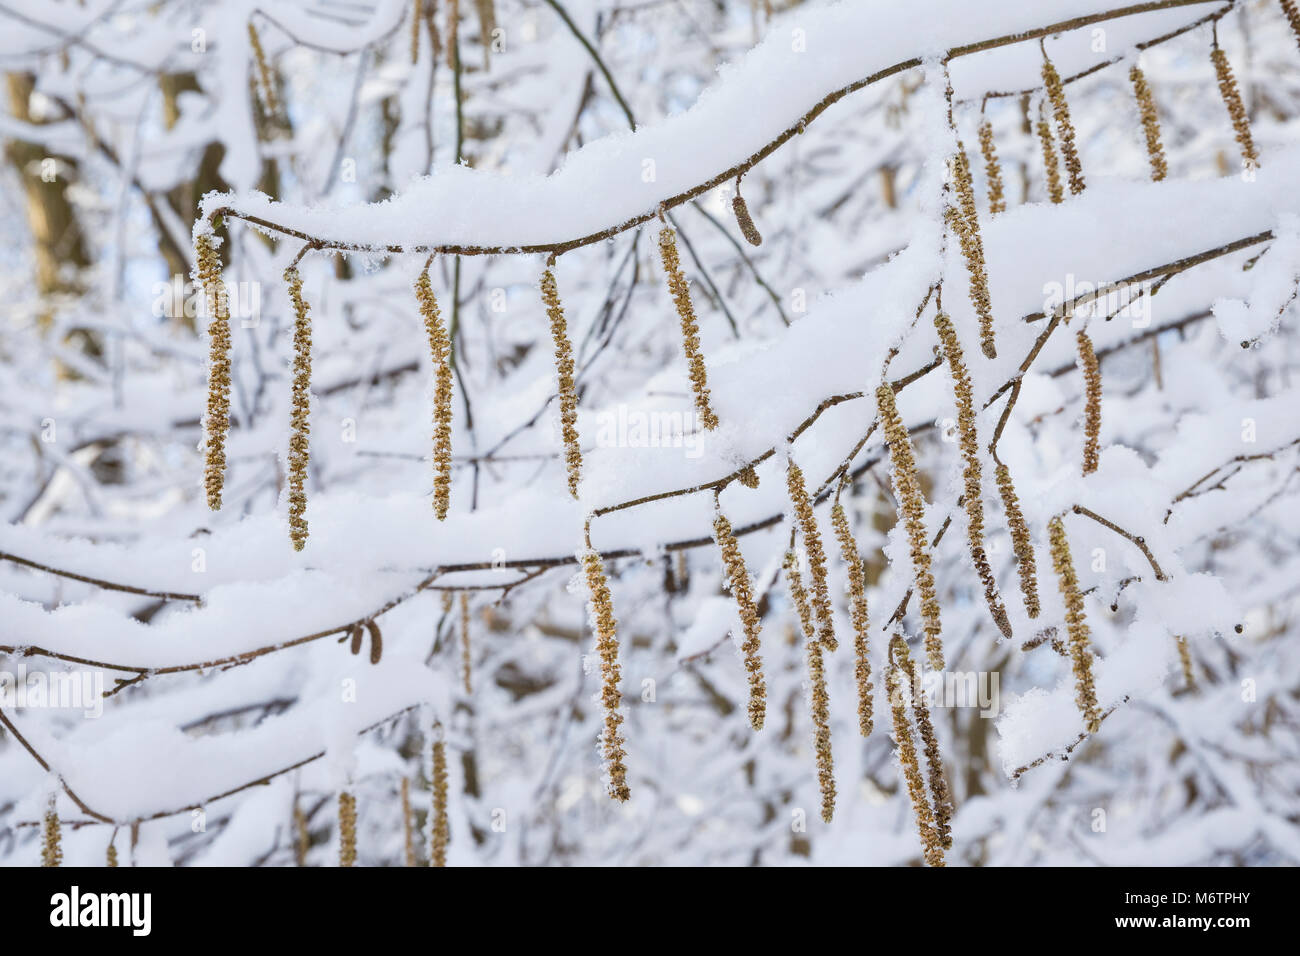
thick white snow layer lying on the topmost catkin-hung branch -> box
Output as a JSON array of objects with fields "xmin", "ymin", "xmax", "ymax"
[{"xmin": 202, "ymin": 0, "xmax": 1216, "ymax": 248}]
